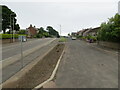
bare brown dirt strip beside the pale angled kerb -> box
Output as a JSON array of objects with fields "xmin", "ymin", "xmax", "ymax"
[{"xmin": 4, "ymin": 44, "xmax": 65, "ymax": 88}]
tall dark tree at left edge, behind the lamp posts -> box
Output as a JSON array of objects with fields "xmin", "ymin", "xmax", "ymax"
[{"xmin": 2, "ymin": 5, "xmax": 20, "ymax": 33}]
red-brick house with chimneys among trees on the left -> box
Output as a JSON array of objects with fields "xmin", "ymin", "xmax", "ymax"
[{"xmin": 26, "ymin": 24, "xmax": 38, "ymax": 38}]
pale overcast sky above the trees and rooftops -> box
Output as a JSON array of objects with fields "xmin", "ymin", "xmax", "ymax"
[{"xmin": 2, "ymin": 0, "xmax": 119, "ymax": 35}]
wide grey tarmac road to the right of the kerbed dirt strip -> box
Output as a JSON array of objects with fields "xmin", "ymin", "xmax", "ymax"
[{"xmin": 55, "ymin": 40, "xmax": 118, "ymax": 88}]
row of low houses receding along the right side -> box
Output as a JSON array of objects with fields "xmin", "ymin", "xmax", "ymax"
[{"xmin": 76, "ymin": 27, "xmax": 100, "ymax": 36}]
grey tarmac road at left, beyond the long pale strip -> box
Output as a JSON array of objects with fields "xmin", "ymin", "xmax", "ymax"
[{"xmin": 2, "ymin": 38, "xmax": 54, "ymax": 60}]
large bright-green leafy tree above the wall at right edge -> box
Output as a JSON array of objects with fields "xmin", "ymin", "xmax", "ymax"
[{"xmin": 98, "ymin": 14, "xmax": 120, "ymax": 42}]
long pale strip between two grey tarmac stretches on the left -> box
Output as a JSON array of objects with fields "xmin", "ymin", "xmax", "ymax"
[{"xmin": 0, "ymin": 39, "xmax": 56, "ymax": 69}]
